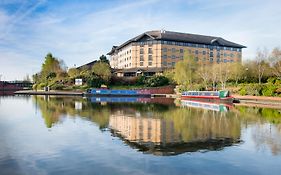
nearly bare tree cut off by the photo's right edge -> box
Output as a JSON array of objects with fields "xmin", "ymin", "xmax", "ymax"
[{"xmin": 270, "ymin": 47, "xmax": 281, "ymax": 79}]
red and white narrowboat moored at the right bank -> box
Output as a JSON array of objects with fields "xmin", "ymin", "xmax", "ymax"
[{"xmin": 181, "ymin": 90, "xmax": 233, "ymax": 103}]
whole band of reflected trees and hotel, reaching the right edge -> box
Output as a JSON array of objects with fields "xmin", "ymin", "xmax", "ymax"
[{"xmin": 33, "ymin": 96, "xmax": 281, "ymax": 155}]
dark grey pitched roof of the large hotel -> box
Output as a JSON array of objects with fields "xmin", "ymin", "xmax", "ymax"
[{"xmin": 108, "ymin": 30, "xmax": 246, "ymax": 55}]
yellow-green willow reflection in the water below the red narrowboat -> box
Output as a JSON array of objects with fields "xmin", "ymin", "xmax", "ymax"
[{"xmin": 161, "ymin": 108, "xmax": 241, "ymax": 144}]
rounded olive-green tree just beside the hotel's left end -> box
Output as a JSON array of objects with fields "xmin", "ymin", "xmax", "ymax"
[{"xmin": 92, "ymin": 62, "xmax": 111, "ymax": 82}]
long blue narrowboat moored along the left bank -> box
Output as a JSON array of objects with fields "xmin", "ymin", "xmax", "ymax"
[{"xmin": 86, "ymin": 89, "xmax": 151, "ymax": 97}]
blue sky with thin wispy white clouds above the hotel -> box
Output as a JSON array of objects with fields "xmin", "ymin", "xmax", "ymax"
[{"xmin": 0, "ymin": 0, "xmax": 281, "ymax": 80}]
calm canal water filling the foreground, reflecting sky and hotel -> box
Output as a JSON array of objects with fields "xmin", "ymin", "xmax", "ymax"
[{"xmin": 0, "ymin": 96, "xmax": 281, "ymax": 175}]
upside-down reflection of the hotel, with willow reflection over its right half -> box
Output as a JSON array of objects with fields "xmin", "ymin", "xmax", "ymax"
[{"xmin": 109, "ymin": 101, "xmax": 241, "ymax": 155}]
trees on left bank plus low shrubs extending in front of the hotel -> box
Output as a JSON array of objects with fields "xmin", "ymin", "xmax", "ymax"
[{"xmin": 33, "ymin": 53, "xmax": 169, "ymax": 90}]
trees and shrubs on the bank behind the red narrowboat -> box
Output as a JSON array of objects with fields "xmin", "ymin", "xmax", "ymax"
[{"xmin": 170, "ymin": 48, "xmax": 281, "ymax": 96}]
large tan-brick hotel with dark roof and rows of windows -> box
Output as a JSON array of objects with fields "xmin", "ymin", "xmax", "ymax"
[{"xmin": 108, "ymin": 30, "xmax": 245, "ymax": 76}]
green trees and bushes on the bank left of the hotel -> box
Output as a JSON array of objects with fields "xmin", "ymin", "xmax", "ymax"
[{"xmin": 33, "ymin": 53, "xmax": 111, "ymax": 90}]
